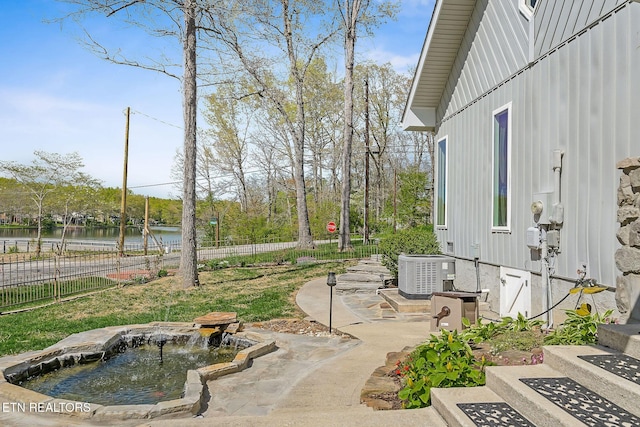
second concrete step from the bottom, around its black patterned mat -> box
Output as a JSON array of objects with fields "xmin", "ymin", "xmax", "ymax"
[{"xmin": 486, "ymin": 364, "xmax": 584, "ymax": 427}]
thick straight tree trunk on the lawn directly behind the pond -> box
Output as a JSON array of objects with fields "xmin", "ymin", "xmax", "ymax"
[{"xmin": 180, "ymin": 0, "xmax": 200, "ymax": 288}]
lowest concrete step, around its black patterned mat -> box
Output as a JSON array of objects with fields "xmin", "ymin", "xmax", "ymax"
[{"xmin": 431, "ymin": 386, "xmax": 528, "ymax": 427}]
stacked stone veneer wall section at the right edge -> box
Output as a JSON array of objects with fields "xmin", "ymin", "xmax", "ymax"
[{"xmin": 615, "ymin": 157, "xmax": 640, "ymax": 323}]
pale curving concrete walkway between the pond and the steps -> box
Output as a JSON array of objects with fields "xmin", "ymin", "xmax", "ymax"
[{"xmin": 141, "ymin": 278, "xmax": 446, "ymax": 427}]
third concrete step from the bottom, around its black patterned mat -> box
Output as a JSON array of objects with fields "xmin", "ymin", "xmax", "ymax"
[{"xmin": 544, "ymin": 346, "xmax": 640, "ymax": 416}]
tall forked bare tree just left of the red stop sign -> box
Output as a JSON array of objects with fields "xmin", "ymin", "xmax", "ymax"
[{"xmin": 204, "ymin": 0, "xmax": 340, "ymax": 248}]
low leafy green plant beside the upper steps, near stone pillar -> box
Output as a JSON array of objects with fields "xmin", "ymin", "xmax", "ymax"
[{"xmin": 544, "ymin": 310, "xmax": 613, "ymax": 345}]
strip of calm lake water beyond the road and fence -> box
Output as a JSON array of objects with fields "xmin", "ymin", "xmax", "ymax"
[{"xmin": 0, "ymin": 226, "xmax": 182, "ymax": 244}]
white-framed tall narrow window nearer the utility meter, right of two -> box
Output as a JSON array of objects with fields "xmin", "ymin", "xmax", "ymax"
[{"xmin": 493, "ymin": 104, "xmax": 511, "ymax": 230}]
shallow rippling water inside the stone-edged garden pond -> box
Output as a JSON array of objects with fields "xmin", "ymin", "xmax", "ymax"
[{"xmin": 20, "ymin": 343, "xmax": 238, "ymax": 406}]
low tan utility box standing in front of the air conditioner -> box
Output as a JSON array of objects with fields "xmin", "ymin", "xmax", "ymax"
[{"xmin": 431, "ymin": 292, "xmax": 480, "ymax": 331}]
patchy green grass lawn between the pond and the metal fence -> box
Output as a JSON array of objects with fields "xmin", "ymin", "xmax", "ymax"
[{"xmin": 0, "ymin": 262, "xmax": 349, "ymax": 356}]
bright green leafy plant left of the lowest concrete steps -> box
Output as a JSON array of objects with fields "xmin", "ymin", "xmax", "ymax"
[{"xmin": 396, "ymin": 330, "xmax": 486, "ymax": 408}]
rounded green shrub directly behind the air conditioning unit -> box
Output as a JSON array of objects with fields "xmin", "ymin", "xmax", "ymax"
[{"xmin": 378, "ymin": 227, "xmax": 440, "ymax": 278}]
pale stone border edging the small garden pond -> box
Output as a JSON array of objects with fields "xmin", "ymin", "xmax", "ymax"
[{"xmin": 0, "ymin": 322, "xmax": 276, "ymax": 421}]
